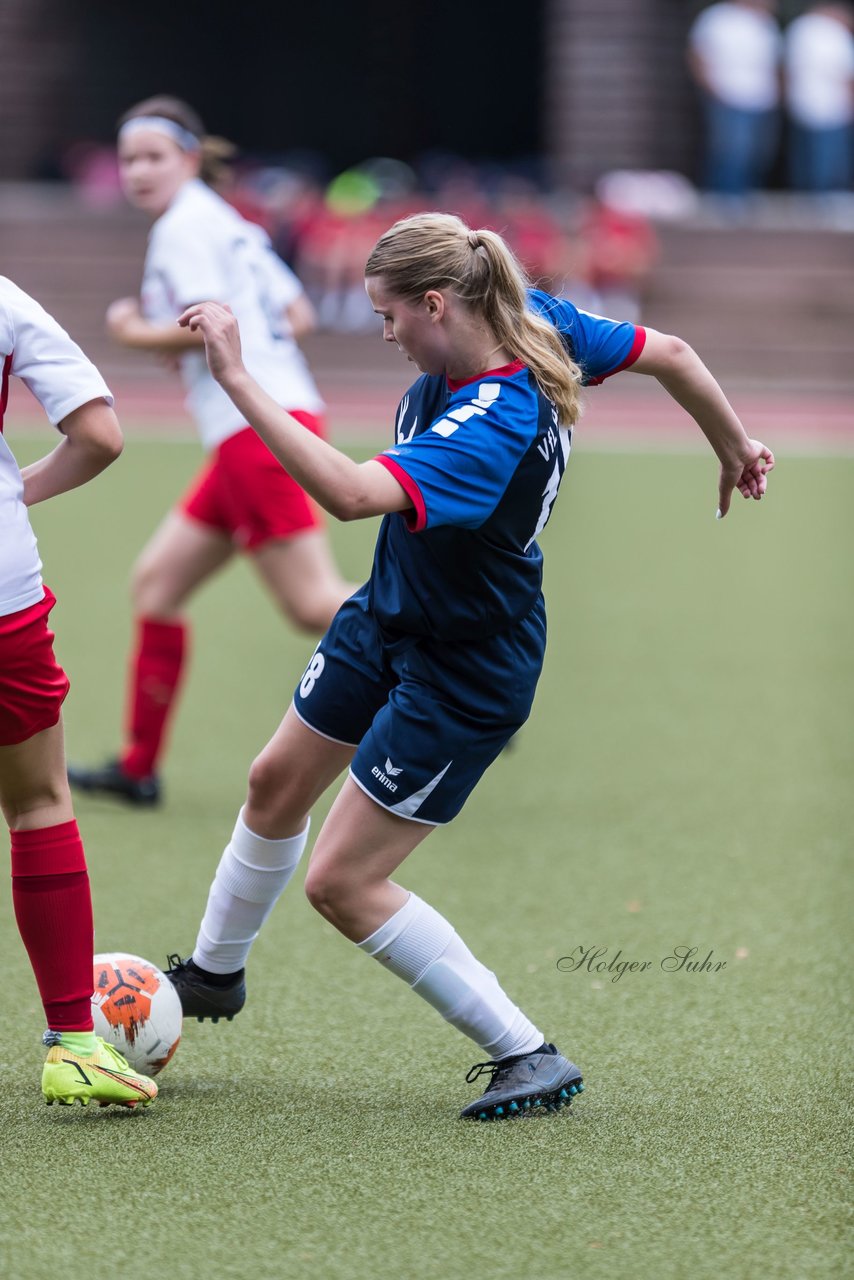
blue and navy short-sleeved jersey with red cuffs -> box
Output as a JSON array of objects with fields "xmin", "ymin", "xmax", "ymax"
[{"xmin": 369, "ymin": 291, "xmax": 644, "ymax": 640}]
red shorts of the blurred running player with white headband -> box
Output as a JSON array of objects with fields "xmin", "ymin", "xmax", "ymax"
[{"xmin": 178, "ymin": 410, "xmax": 324, "ymax": 550}]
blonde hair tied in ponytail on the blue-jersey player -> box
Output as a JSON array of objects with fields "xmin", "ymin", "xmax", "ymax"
[{"xmin": 365, "ymin": 214, "xmax": 581, "ymax": 426}]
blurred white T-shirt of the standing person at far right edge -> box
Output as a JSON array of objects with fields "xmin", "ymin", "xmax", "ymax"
[{"xmin": 786, "ymin": 13, "xmax": 854, "ymax": 129}]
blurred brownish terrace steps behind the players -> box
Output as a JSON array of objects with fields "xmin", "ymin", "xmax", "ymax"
[{"xmin": 0, "ymin": 186, "xmax": 854, "ymax": 394}]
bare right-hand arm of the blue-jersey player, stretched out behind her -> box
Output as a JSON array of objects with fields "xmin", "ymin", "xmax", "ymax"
[{"xmin": 629, "ymin": 329, "xmax": 775, "ymax": 518}]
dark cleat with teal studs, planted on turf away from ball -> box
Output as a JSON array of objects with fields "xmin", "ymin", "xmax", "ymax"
[{"xmin": 460, "ymin": 1044, "xmax": 584, "ymax": 1120}]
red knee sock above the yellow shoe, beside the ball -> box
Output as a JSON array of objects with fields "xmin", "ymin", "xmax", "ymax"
[{"xmin": 12, "ymin": 820, "xmax": 93, "ymax": 1032}]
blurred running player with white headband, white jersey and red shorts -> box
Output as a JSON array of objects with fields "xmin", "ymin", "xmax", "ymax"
[{"xmin": 69, "ymin": 97, "xmax": 352, "ymax": 805}]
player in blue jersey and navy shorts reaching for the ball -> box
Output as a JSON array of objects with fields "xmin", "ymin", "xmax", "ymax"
[{"xmin": 163, "ymin": 214, "xmax": 773, "ymax": 1120}]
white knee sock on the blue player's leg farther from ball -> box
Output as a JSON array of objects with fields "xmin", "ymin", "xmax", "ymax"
[{"xmin": 359, "ymin": 893, "xmax": 543, "ymax": 1059}]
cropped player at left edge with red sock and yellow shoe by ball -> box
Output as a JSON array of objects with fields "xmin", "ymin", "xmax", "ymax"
[{"xmin": 0, "ymin": 276, "xmax": 157, "ymax": 1107}]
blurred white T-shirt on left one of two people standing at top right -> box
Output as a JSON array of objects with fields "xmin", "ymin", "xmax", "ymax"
[{"xmin": 689, "ymin": 0, "xmax": 782, "ymax": 111}]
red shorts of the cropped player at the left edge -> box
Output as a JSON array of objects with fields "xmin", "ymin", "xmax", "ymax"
[{"xmin": 0, "ymin": 588, "xmax": 69, "ymax": 746}]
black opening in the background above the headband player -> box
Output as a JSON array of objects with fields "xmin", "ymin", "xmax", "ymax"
[{"xmin": 65, "ymin": 0, "xmax": 543, "ymax": 170}]
